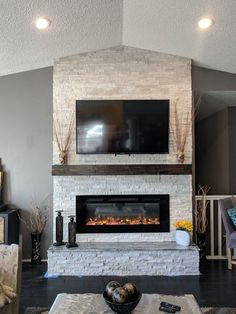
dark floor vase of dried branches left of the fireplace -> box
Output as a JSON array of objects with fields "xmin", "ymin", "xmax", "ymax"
[{"xmin": 20, "ymin": 203, "xmax": 48, "ymax": 265}]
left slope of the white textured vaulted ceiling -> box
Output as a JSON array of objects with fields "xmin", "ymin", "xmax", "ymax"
[{"xmin": 0, "ymin": 0, "xmax": 122, "ymax": 75}]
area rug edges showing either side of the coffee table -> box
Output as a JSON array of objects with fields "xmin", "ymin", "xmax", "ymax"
[{"xmin": 25, "ymin": 307, "xmax": 236, "ymax": 314}]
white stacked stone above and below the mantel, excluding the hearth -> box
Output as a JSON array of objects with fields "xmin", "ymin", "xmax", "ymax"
[{"xmin": 53, "ymin": 46, "xmax": 192, "ymax": 241}]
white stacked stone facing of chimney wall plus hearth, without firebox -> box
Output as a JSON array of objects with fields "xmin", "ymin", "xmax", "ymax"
[{"xmin": 48, "ymin": 46, "xmax": 198, "ymax": 276}]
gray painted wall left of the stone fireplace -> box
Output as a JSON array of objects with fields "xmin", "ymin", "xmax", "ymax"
[{"xmin": 0, "ymin": 67, "xmax": 52, "ymax": 258}]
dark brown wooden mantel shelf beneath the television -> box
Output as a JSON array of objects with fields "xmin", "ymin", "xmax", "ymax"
[{"xmin": 52, "ymin": 164, "xmax": 192, "ymax": 176}]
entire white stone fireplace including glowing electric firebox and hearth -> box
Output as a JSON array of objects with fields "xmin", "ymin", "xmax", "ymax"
[{"xmin": 48, "ymin": 46, "xmax": 198, "ymax": 275}]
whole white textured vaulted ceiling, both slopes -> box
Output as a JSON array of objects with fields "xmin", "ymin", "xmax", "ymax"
[{"xmin": 0, "ymin": 0, "xmax": 236, "ymax": 75}]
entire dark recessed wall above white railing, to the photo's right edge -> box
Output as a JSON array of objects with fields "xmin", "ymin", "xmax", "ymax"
[{"xmin": 196, "ymin": 107, "xmax": 236, "ymax": 195}]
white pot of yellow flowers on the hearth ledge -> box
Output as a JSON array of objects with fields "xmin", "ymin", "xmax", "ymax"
[{"xmin": 174, "ymin": 220, "xmax": 193, "ymax": 246}]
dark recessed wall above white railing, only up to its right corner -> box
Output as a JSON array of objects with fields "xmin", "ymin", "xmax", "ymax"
[{"xmin": 196, "ymin": 108, "xmax": 229, "ymax": 195}]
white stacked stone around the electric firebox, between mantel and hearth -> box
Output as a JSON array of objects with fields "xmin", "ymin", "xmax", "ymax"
[{"xmin": 54, "ymin": 175, "xmax": 192, "ymax": 242}]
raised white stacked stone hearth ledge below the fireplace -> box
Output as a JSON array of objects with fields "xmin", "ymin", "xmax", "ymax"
[{"xmin": 48, "ymin": 242, "xmax": 199, "ymax": 276}]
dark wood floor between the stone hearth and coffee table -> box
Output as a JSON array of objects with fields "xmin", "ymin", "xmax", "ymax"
[{"xmin": 20, "ymin": 261, "xmax": 236, "ymax": 314}]
